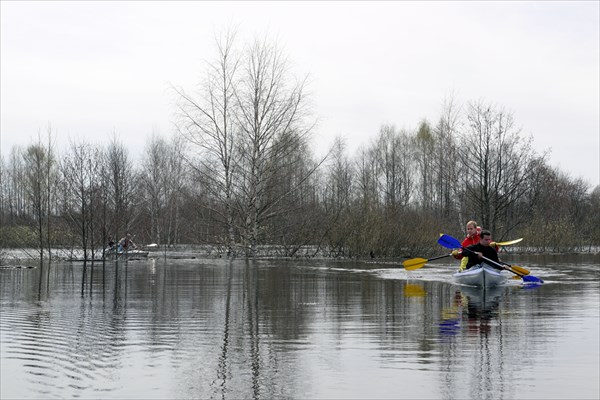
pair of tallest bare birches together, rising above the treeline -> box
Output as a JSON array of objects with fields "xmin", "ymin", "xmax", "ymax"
[{"xmin": 175, "ymin": 33, "xmax": 314, "ymax": 256}]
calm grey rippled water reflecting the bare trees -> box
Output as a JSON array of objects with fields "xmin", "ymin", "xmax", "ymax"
[{"xmin": 0, "ymin": 256, "xmax": 600, "ymax": 399}]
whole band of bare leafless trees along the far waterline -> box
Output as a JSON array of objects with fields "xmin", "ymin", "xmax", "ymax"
[{"xmin": 0, "ymin": 35, "xmax": 600, "ymax": 257}]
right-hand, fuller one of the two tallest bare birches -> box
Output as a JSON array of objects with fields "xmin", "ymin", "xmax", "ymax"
[{"xmin": 235, "ymin": 39, "xmax": 312, "ymax": 256}]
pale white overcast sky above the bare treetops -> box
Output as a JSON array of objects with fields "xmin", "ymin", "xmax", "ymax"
[{"xmin": 0, "ymin": 0, "xmax": 600, "ymax": 186}]
